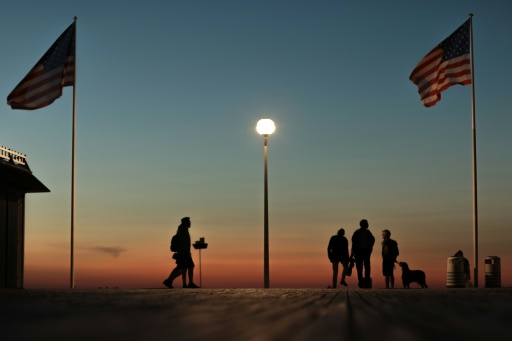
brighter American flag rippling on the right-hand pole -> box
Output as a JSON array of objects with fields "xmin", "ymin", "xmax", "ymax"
[{"xmin": 409, "ymin": 19, "xmax": 472, "ymax": 107}]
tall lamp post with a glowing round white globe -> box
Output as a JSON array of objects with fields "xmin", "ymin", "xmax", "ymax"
[{"xmin": 256, "ymin": 119, "xmax": 276, "ymax": 288}]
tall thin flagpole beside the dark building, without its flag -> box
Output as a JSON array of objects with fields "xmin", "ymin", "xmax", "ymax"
[{"xmin": 70, "ymin": 16, "xmax": 77, "ymax": 289}]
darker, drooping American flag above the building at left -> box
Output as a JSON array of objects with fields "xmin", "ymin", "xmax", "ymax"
[{"xmin": 7, "ymin": 22, "xmax": 76, "ymax": 110}]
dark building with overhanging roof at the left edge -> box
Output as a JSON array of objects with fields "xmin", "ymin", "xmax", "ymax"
[{"xmin": 0, "ymin": 147, "xmax": 50, "ymax": 288}]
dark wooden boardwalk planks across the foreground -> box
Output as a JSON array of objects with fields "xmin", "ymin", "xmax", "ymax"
[{"xmin": 0, "ymin": 288, "xmax": 512, "ymax": 341}]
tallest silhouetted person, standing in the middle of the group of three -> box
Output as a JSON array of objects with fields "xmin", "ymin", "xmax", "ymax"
[{"xmin": 350, "ymin": 219, "xmax": 375, "ymax": 288}]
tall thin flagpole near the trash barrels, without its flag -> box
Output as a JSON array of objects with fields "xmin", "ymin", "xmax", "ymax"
[{"xmin": 469, "ymin": 13, "xmax": 478, "ymax": 288}]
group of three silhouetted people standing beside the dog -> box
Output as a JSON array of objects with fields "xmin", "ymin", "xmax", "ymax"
[{"xmin": 327, "ymin": 219, "xmax": 399, "ymax": 288}]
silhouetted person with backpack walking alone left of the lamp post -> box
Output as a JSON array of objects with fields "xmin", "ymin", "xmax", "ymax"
[{"xmin": 163, "ymin": 217, "xmax": 199, "ymax": 288}]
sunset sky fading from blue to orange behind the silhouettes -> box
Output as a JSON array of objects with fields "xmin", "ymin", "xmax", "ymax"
[{"xmin": 0, "ymin": 0, "xmax": 512, "ymax": 288}]
